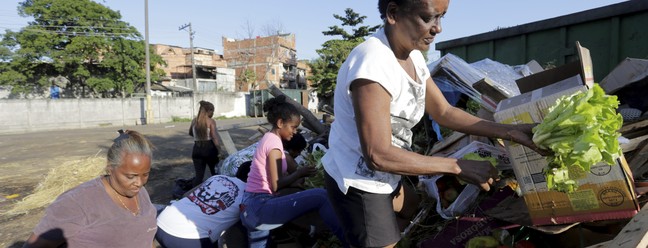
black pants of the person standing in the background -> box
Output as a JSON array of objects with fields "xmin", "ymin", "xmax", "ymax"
[{"xmin": 191, "ymin": 140, "xmax": 218, "ymax": 187}]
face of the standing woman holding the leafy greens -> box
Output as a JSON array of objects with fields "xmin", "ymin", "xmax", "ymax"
[{"xmin": 394, "ymin": 0, "xmax": 449, "ymax": 53}]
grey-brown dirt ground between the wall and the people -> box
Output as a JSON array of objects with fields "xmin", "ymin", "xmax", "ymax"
[{"xmin": 0, "ymin": 118, "xmax": 265, "ymax": 247}]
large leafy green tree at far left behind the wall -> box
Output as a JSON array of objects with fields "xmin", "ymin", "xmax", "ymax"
[{"xmin": 0, "ymin": 0, "xmax": 163, "ymax": 97}]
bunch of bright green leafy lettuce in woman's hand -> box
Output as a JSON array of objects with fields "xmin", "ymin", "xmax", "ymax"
[{"xmin": 533, "ymin": 84, "xmax": 623, "ymax": 192}]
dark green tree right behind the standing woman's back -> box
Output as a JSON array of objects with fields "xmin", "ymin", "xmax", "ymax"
[{"xmin": 309, "ymin": 8, "xmax": 380, "ymax": 98}]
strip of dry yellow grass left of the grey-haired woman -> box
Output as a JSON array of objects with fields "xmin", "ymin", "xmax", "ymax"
[{"xmin": 5, "ymin": 156, "xmax": 106, "ymax": 215}]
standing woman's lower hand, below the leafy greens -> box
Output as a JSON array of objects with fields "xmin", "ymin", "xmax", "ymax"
[{"xmin": 457, "ymin": 160, "xmax": 499, "ymax": 191}]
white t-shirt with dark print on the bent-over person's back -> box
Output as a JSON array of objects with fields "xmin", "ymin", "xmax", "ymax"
[{"xmin": 157, "ymin": 175, "xmax": 245, "ymax": 242}]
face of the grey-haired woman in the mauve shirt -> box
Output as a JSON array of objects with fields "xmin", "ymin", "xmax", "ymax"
[{"xmin": 108, "ymin": 153, "xmax": 151, "ymax": 197}]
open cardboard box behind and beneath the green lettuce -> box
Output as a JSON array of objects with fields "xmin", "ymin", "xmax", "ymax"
[{"xmin": 494, "ymin": 42, "xmax": 639, "ymax": 225}]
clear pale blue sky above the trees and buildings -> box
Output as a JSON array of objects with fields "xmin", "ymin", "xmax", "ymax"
[{"xmin": 0, "ymin": 0, "xmax": 624, "ymax": 59}]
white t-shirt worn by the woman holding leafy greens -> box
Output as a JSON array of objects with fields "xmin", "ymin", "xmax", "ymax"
[{"xmin": 322, "ymin": 29, "xmax": 430, "ymax": 194}]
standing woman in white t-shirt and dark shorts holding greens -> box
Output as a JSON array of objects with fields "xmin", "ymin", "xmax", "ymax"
[{"xmin": 322, "ymin": 0, "xmax": 539, "ymax": 247}]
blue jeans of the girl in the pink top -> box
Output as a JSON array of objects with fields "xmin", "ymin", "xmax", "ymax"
[{"xmin": 241, "ymin": 188, "xmax": 346, "ymax": 248}]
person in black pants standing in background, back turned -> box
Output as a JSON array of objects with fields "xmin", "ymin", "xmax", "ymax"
[{"xmin": 189, "ymin": 100, "xmax": 220, "ymax": 187}]
